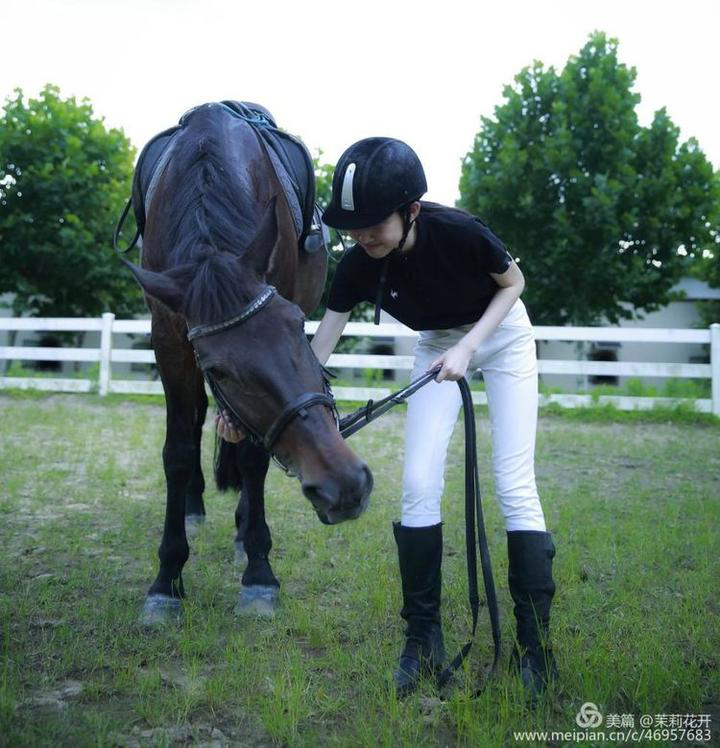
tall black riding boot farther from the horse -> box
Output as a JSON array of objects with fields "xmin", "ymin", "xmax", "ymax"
[{"xmin": 507, "ymin": 530, "xmax": 557, "ymax": 697}]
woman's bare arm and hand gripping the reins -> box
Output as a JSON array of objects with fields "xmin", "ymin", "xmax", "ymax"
[{"xmin": 428, "ymin": 262, "xmax": 525, "ymax": 382}]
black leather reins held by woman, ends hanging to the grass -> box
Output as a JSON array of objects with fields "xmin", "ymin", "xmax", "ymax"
[{"xmin": 340, "ymin": 367, "xmax": 501, "ymax": 696}]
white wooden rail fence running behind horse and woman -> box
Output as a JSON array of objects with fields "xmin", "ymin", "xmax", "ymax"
[{"xmin": 0, "ymin": 313, "xmax": 720, "ymax": 416}]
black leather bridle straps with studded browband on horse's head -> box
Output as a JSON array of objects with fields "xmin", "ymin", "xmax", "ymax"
[{"xmin": 187, "ymin": 286, "xmax": 338, "ymax": 472}]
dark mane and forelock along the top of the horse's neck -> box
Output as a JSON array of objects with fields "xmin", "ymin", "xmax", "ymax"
[{"xmin": 159, "ymin": 117, "xmax": 268, "ymax": 321}]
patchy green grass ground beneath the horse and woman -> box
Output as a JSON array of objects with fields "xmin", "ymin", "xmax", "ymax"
[{"xmin": 0, "ymin": 395, "xmax": 720, "ymax": 746}]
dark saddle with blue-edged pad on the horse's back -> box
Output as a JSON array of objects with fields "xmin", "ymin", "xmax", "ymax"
[{"xmin": 113, "ymin": 100, "xmax": 330, "ymax": 253}]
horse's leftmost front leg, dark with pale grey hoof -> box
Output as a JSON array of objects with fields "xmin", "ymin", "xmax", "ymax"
[{"xmin": 142, "ymin": 372, "xmax": 197, "ymax": 625}]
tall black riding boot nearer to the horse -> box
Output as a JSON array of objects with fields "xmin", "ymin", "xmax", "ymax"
[{"xmin": 393, "ymin": 522, "xmax": 445, "ymax": 698}]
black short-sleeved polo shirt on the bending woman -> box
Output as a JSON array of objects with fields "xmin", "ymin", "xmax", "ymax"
[{"xmin": 327, "ymin": 202, "xmax": 512, "ymax": 330}]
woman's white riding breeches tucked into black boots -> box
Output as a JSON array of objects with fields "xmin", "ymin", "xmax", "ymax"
[{"xmin": 402, "ymin": 299, "xmax": 546, "ymax": 531}]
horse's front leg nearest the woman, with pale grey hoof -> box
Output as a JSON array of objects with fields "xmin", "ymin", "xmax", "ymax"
[{"xmin": 235, "ymin": 445, "xmax": 280, "ymax": 616}]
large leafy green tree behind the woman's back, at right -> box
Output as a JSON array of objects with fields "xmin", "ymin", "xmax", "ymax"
[{"xmin": 459, "ymin": 32, "xmax": 720, "ymax": 325}]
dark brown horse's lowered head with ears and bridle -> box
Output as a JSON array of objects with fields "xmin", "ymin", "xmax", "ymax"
[{"xmin": 128, "ymin": 201, "xmax": 373, "ymax": 524}]
